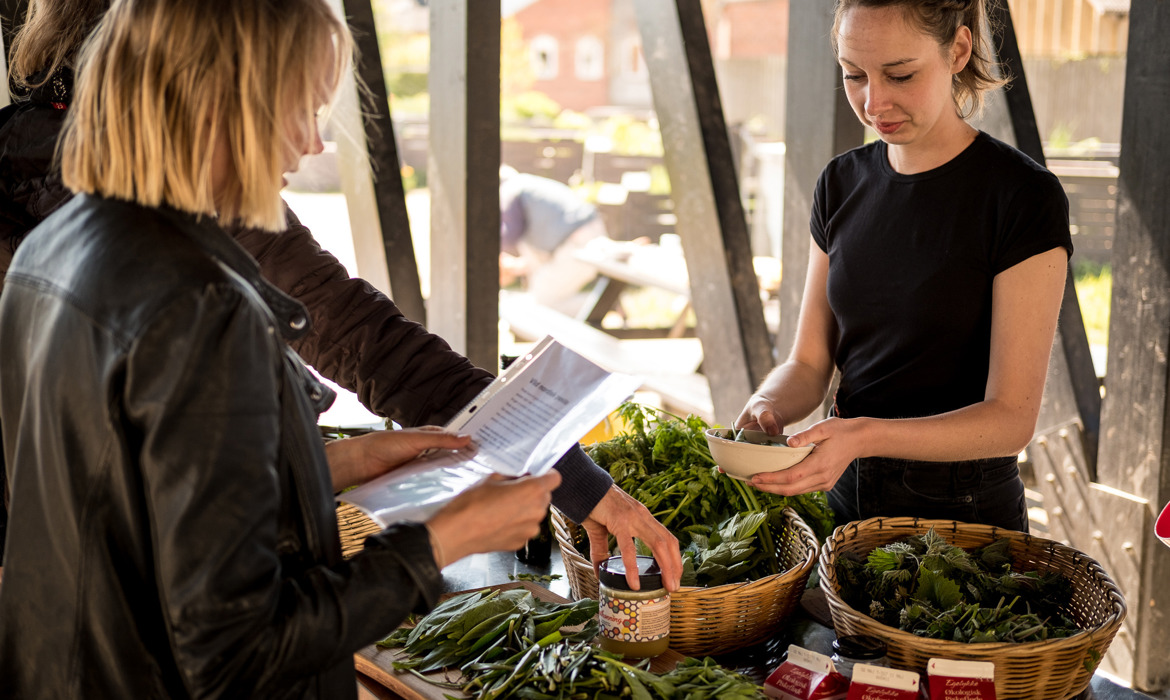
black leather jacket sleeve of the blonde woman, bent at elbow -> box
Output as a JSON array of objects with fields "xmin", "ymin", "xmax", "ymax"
[{"xmin": 124, "ymin": 287, "xmax": 441, "ymax": 698}]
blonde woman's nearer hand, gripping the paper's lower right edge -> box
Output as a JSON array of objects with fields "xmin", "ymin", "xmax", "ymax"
[{"xmin": 427, "ymin": 469, "xmax": 560, "ymax": 569}]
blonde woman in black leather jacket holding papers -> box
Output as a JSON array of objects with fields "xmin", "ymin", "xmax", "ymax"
[{"xmin": 0, "ymin": 0, "xmax": 559, "ymax": 699}]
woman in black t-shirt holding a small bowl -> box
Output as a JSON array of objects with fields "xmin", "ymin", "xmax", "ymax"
[{"xmin": 736, "ymin": 0, "xmax": 1072, "ymax": 530}]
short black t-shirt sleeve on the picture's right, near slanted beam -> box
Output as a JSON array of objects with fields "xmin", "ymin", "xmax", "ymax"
[{"xmin": 992, "ymin": 171, "xmax": 1073, "ymax": 275}]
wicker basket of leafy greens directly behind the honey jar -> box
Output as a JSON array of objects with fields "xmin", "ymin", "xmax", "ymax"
[{"xmin": 552, "ymin": 508, "xmax": 817, "ymax": 656}]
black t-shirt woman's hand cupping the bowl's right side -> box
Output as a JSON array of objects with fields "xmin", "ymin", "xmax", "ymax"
[{"xmin": 751, "ymin": 418, "xmax": 866, "ymax": 496}]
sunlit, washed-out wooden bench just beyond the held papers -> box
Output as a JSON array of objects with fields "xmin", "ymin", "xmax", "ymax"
[{"xmin": 500, "ymin": 291, "xmax": 715, "ymax": 423}]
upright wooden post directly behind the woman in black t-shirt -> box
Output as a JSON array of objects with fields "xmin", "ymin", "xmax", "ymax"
[{"xmin": 776, "ymin": 0, "xmax": 865, "ymax": 425}]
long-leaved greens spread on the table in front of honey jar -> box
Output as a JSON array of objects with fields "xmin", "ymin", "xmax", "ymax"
[{"xmin": 378, "ymin": 589, "xmax": 764, "ymax": 700}]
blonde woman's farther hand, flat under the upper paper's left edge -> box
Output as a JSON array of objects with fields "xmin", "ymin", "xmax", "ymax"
[{"xmin": 325, "ymin": 426, "xmax": 472, "ymax": 493}]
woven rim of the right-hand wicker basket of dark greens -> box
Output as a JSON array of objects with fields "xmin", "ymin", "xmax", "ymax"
[{"xmin": 818, "ymin": 517, "xmax": 1128, "ymax": 653}]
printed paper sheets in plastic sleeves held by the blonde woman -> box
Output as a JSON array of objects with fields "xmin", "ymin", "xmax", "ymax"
[{"xmin": 339, "ymin": 338, "xmax": 641, "ymax": 527}]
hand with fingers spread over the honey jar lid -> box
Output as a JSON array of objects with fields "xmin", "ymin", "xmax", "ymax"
[{"xmin": 581, "ymin": 485, "xmax": 682, "ymax": 591}]
